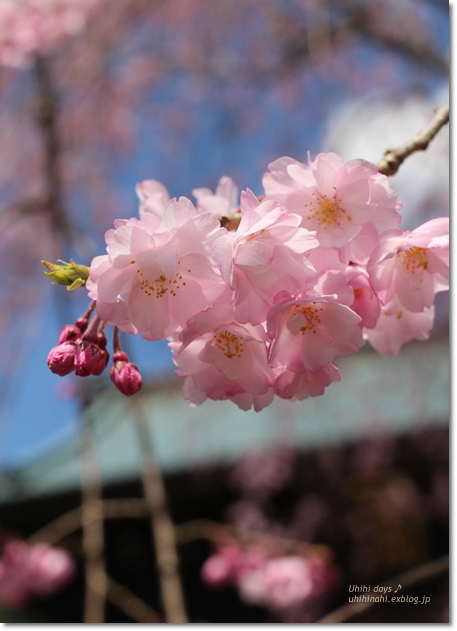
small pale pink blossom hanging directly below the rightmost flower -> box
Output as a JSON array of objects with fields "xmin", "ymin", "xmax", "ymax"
[{"xmin": 364, "ymin": 297, "xmax": 435, "ymax": 356}]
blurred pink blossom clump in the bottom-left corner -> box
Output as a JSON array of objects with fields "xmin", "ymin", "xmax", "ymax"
[{"xmin": 0, "ymin": 540, "xmax": 75, "ymax": 609}]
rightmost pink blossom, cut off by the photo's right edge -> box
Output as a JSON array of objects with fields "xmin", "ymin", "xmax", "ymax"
[{"xmin": 367, "ymin": 217, "xmax": 449, "ymax": 313}]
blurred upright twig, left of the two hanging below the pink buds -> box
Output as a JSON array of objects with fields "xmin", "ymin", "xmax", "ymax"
[{"xmin": 80, "ymin": 394, "xmax": 107, "ymax": 624}]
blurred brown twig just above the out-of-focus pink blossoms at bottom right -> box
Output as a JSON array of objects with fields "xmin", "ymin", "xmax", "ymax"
[{"xmin": 175, "ymin": 519, "xmax": 333, "ymax": 561}]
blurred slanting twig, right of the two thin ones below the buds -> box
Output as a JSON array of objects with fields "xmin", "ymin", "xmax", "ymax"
[{"xmin": 133, "ymin": 401, "xmax": 188, "ymax": 624}]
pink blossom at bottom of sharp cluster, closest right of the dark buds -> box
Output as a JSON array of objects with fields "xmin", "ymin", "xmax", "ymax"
[{"xmin": 170, "ymin": 303, "xmax": 274, "ymax": 410}]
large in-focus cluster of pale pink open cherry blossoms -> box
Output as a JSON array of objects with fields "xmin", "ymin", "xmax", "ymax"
[{"xmin": 78, "ymin": 153, "xmax": 449, "ymax": 410}]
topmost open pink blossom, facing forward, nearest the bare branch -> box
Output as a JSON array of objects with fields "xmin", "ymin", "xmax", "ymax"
[{"xmin": 263, "ymin": 153, "xmax": 401, "ymax": 263}]
